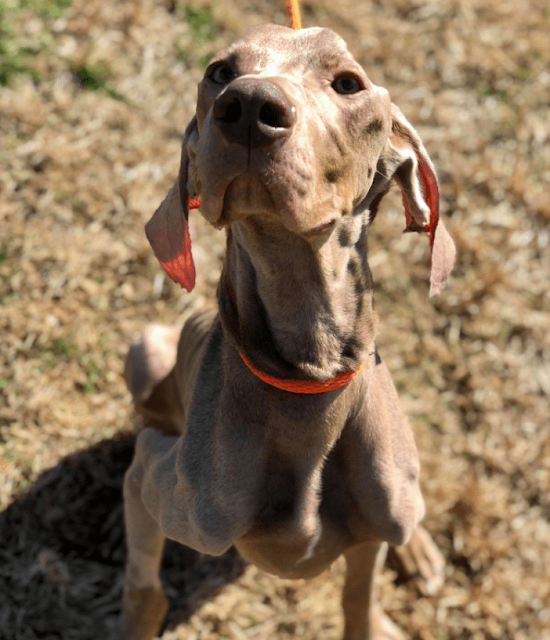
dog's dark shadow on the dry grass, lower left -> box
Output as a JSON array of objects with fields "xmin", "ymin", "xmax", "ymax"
[{"xmin": 0, "ymin": 434, "xmax": 245, "ymax": 640}]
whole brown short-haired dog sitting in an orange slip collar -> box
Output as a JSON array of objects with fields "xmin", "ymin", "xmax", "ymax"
[{"xmin": 121, "ymin": 25, "xmax": 455, "ymax": 640}]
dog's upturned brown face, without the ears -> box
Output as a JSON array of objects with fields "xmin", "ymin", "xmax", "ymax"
[{"xmin": 187, "ymin": 25, "xmax": 391, "ymax": 235}]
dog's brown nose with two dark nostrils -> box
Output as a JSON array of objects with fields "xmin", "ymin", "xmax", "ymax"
[{"xmin": 213, "ymin": 78, "xmax": 296, "ymax": 148}]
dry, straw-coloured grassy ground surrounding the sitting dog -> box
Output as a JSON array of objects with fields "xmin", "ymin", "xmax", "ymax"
[{"xmin": 0, "ymin": 0, "xmax": 550, "ymax": 640}]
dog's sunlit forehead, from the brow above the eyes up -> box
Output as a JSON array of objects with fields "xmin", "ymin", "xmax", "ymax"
[{"xmin": 216, "ymin": 24, "xmax": 364, "ymax": 73}]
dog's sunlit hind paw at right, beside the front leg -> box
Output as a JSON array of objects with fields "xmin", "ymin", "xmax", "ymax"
[{"xmin": 388, "ymin": 526, "xmax": 445, "ymax": 596}]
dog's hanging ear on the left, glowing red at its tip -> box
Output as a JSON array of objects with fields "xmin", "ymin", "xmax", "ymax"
[{"xmin": 145, "ymin": 118, "xmax": 200, "ymax": 291}]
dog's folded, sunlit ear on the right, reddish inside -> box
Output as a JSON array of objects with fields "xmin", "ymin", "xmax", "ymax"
[{"xmin": 389, "ymin": 104, "xmax": 456, "ymax": 296}]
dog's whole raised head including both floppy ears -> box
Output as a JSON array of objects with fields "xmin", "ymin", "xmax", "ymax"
[{"xmin": 146, "ymin": 25, "xmax": 455, "ymax": 295}]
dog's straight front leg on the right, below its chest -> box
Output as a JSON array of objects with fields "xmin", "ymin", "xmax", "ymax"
[{"xmin": 342, "ymin": 542, "xmax": 405, "ymax": 640}]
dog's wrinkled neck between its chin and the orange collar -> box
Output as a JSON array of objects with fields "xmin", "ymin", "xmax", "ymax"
[{"xmin": 218, "ymin": 216, "xmax": 376, "ymax": 381}]
